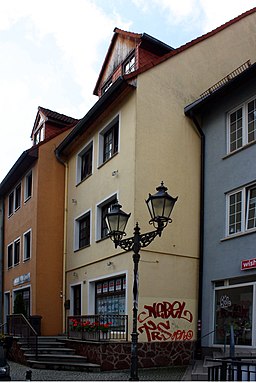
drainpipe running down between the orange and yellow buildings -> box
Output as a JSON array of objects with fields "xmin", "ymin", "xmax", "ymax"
[{"xmin": 55, "ymin": 150, "xmax": 68, "ymax": 333}]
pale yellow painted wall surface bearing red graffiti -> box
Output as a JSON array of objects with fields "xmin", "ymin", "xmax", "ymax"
[{"xmin": 66, "ymin": 11, "xmax": 256, "ymax": 341}]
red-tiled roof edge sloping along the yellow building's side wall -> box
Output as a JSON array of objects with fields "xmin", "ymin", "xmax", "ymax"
[{"xmin": 124, "ymin": 7, "xmax": 256, "ymax": 79}]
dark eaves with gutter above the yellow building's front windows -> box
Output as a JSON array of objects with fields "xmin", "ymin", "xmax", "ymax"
[{"xmin": 55, "ymin": 77, "xmax": 134, "ymax": 156}]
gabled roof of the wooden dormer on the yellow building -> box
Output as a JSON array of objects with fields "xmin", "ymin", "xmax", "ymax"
[{"xmin": 93, "ymin": 28, "xmax": 174, "ymax": 95}]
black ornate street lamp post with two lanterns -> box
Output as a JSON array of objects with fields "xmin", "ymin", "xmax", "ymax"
[{"xmin": 105, "ymin": 182, "xmax": 178, "ymax": 380}]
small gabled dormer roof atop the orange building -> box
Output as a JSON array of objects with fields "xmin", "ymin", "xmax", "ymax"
[{"xmin": 31, "ymin": 106, "xmax": 79, "ymax": 137}]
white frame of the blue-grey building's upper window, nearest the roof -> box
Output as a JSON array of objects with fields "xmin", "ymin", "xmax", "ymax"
[{"xmin": 227, "ymin": 96, "xmax": 256, "ymax": 154}]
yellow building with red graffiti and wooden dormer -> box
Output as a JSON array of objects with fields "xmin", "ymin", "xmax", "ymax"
[{"xmin": 57, "ymin": 10, "xmax": 256, "ymax": 366}]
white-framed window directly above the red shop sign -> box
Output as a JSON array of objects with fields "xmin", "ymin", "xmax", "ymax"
[{"xmin": 227, "ymin": 185, "xmax": 256, "ymax": 235}]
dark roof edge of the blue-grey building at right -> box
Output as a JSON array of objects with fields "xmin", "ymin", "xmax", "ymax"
[{"xmin": 184, "ymin": 63, "xmax": 256, "ymax": 116}]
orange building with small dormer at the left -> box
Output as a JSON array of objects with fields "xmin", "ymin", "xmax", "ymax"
[{"xmin": 0, "ymin": 107, "xmax": 77, "ymax": 335}]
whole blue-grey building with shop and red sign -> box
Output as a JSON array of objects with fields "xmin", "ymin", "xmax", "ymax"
[{"xmin": 185, "ymin": 62, "xmax": 256, "ymax": 349}]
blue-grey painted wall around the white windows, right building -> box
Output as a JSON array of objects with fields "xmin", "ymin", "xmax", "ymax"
[{"xmin": 196, "ymin": 76, "xmax": 256, "ymax": 346}]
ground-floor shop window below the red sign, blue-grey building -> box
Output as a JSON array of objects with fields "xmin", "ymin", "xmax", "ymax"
[{"xmin": 214, "ymin": 285, "xmax": 253, "ymax": 346}]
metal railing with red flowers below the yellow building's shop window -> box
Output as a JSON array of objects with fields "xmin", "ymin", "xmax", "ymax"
[{"xmin": 67, "ymin": 315, "xmax": 128, "ymax": 342}]
